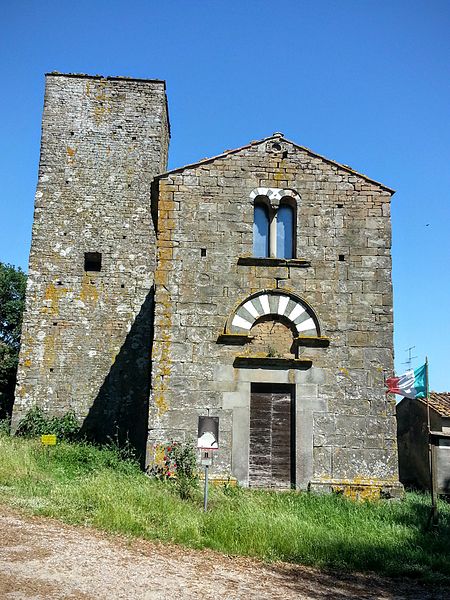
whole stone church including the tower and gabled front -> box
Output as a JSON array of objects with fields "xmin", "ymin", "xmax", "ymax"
[{"xmin": 13, "ymin": 73, "xmax": 401, "ymax": 495}]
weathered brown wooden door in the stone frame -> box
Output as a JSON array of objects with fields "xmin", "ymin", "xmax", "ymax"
[{"xmin": 249, "ymin": 384, "xmax": 295, "ymax": 488}]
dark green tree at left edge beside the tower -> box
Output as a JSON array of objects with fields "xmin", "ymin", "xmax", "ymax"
[{"xmin": 0, "ymin": 262, "xmax": 27, "ymax": 419}]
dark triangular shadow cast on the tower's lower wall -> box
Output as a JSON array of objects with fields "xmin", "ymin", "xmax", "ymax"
[{"xmin": 81, "ymin": 288, "xmax": 155, "ymax": 467}]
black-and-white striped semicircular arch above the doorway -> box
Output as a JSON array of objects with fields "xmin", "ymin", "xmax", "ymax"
[{"xmin": 227, "ymin": 290, "xmax": 320, "ymax": 337}]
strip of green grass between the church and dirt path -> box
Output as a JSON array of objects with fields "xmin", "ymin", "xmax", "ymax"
[{"xmin": 0, "ymin": 436, "xmax": 450, "ymax": 583}]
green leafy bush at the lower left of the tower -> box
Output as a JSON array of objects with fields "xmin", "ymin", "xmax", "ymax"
[{"xmin": 16, "ymin": 406, "xmax": 80, "ymax": 441}]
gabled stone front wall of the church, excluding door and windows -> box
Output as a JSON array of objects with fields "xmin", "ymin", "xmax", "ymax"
[{"xmin": 149, "ymin": 138, "xmax": 398, "ymax": 489}]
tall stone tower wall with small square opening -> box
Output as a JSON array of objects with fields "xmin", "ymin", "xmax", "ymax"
[{"xmin": 13, "ymin": 74, "xmax": 169, "ymax": 460}]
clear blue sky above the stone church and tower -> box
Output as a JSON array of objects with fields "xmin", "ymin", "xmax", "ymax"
[{"xmin": 0, "ymin": 0, "xmax": 450, "ymax": 391}]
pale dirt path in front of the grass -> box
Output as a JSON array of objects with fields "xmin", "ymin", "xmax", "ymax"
[{"xmin": 0, "ymin": 507, "xmax": 444, "ymax": 600}]
